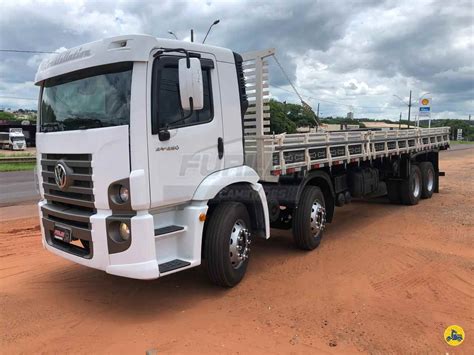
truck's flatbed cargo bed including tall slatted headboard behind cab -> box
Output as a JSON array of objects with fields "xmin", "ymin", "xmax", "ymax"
[{"xmin": 243, "ymin": 49, "xmax": 449, "ymax": 182}]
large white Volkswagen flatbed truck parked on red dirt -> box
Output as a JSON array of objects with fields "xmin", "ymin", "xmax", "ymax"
[{"xmin": 35, "ymin": 35, "xmax": 449, "ymax": 287}]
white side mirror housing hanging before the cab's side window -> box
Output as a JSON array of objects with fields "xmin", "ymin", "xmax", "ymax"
[{"xmin": 178, "ymin": 58, "xmax": 204, "ymax": 112}]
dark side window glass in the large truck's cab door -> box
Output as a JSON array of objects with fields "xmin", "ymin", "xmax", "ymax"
[{"xmin": 152, "ymin": 57, "xmax": 214, "ymax": 134}]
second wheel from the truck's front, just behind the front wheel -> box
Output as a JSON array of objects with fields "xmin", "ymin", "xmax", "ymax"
[{"xmin": 293, "ymin": 186, "xmax": 326, "ymax": 250}]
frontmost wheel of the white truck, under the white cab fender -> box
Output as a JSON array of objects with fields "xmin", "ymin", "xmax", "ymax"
[{"xmin": 204, "ymin": 202, "xmax": 251, "ymax": 287}]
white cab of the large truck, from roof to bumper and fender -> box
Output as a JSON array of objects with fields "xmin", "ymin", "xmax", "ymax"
[{"xmin": 35, "ymin": 35, "xmax": 269, "ymax": 285}]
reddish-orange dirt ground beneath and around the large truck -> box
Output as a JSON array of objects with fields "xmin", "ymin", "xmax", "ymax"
[{"xmin": 0, "ymin": 149, "xmax": 474, "ymax": 354}]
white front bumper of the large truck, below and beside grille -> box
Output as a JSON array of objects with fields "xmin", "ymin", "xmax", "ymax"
[{"xmin": 38, "ymin": 201, "xmax": 160, "ymax": 280}]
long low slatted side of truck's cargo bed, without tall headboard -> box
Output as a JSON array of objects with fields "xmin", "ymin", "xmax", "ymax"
[{"xmin": 245, "ymin": 127, "xmax": 449, "ymax": 182}]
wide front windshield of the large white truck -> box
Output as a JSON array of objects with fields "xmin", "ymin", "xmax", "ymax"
[{"xmin": 40, "ymin": 62, "xmax": 133, "ymax": 132}]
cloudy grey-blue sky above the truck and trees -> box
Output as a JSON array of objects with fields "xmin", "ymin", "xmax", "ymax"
[{"xmin": 0, "ymin": 0, "xmax": 474, "ymax": 119}]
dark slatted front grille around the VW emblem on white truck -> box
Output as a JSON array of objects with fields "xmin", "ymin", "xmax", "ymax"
[{"xmin": 41, "ymin": 154, "xmax": 96, "ymax": 258}]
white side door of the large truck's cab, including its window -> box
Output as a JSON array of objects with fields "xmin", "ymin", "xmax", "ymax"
[{"xmin": 148, "ymin": 54, "xmax": 224, "ymax": 207}]
